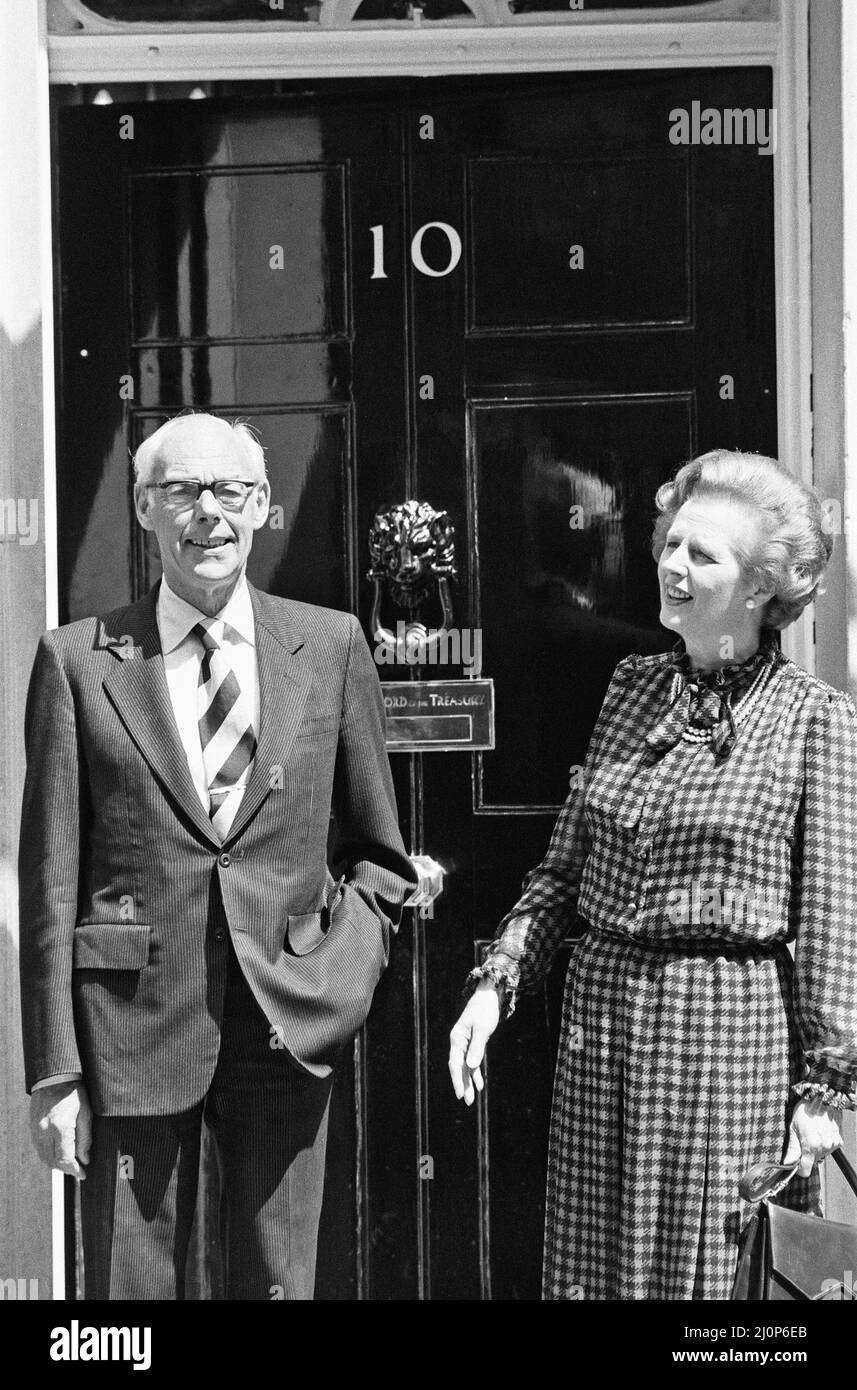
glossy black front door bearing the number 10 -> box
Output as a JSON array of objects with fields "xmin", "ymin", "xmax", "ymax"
[{"xmin": 58, "ymin": 68, "xmax": 776, "ymax": 1298}]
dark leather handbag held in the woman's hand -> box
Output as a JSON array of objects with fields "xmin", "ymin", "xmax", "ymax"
[{"xmin": 732, "ymin": 1150, "xmax": 857, "ymax": 1302}]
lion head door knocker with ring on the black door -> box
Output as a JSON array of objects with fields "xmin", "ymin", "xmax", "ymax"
[{"xmin": 367, "ymin": 502, "xmax": 456, "ymax": 666}]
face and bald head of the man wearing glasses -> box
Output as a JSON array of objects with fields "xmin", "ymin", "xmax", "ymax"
[{"xmin": 135, "ymin": 416, "xmax": 269, "ymax": 612}]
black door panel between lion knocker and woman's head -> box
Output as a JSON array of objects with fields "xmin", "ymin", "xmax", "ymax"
[{"xmin": 472, "ymin": 393, "xmax": 692, "ymax": 808}]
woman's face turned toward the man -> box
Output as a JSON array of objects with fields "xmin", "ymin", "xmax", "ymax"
[{"xmin": 657, "ymin": 498, "xmax": 768, "ymax": 646}]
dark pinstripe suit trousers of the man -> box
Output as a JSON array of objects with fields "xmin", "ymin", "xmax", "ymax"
[{"xmin": 81, "ymin": 944, "xmax": 332, "ymax": 1300}]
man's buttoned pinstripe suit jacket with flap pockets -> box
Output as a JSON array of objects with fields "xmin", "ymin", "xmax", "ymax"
[{"xmin": 19, "ymin": 587, "xmax": 415, "ymax": 1115}]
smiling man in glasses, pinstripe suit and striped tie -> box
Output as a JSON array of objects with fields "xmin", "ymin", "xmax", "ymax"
[{"xmin": 19, "ymin": 414, "xmax": 417, "ymax": 1300}]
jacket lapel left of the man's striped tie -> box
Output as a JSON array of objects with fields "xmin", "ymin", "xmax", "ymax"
[{"xmin": 103, "ymin": 585, "xmax": 221, "ymax": 845}]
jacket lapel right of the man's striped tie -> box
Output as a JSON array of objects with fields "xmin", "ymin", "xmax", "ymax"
[{"xmin": 226, "ymin": 585, "xmax": 313, "ymax": 841}]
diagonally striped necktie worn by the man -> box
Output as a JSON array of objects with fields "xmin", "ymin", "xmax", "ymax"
[{"xmin": 193, "ymin": 620, "xmax": 256, "ymax": 840}]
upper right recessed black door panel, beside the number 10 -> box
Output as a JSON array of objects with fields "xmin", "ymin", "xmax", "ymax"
[{"xmin": 468, "ymin": 158, "xmax": 690, "ymax": 329}]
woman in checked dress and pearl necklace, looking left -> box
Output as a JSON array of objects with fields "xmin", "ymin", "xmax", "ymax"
[{"xmin": 450, "ymin": 450, "xmax": 857, "ymax": 1300}]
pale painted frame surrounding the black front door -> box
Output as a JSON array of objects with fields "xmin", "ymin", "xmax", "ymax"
[{"xmin": 39, "ymin": 0, "xmax": 816, "ymax": 1300}]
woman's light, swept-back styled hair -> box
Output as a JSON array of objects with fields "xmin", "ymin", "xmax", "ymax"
[{"xmin": 651, "ymin": 449, "xmax": 833, "ymax": 630}]
